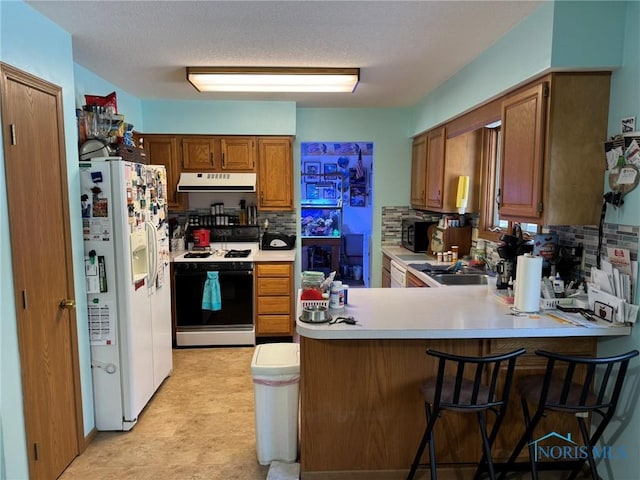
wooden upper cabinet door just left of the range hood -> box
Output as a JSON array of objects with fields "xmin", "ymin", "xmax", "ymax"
[{"xmin": 144, "ymin": 135, "xmax": 187, "ymax": 210}]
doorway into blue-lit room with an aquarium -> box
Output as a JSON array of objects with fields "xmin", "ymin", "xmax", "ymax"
[{"xmin": 300, "ymin": 142, "xmax": 374, "ymax": 287}]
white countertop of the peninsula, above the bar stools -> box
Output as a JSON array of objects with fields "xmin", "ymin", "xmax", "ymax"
[{"xmin": 296, "ymin": 285, "xmax": 631, "ymax": 340}]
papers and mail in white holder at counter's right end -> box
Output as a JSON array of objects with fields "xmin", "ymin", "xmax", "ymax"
[{"xmin": 588, "ymin": 247, "xmax": 640, "ymax": 323}]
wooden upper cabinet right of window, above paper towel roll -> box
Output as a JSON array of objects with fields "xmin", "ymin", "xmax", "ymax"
[{"xmin": 498, "ymin": 72, "xmax": 611, "ymax": 225}]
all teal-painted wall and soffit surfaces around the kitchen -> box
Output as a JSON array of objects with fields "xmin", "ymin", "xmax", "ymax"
[{"xmin": 0, "ymin": 1, "xmax": 640, "ymax": 480}]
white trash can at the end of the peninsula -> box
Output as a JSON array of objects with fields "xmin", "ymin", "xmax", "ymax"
[{"xmin": 251, "ymin": 343, "xmax": 300, "ymax": 465}]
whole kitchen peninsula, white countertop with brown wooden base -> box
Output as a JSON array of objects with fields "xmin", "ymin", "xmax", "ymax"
[{"xmin": 297, "ymin": 285, "xmax": 631, "ymax": 479}]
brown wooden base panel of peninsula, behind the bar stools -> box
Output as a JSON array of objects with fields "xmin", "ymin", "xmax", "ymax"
[{"xmin": 300, "ymin": 337, "xmax": 596, "ymax": 479}]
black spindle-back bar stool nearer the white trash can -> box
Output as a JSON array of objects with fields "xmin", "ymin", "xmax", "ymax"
[{"xmin": 407, "ymin": 348, "xmax": 525, "ymax": 480}]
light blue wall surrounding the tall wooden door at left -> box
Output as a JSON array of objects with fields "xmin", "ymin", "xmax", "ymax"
[{"xmin": 0, "ymin": 1, "xmax": 95, "ymax": 480}]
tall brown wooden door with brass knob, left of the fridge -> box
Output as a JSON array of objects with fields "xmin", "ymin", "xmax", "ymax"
[{"xmin": 0, "ymin": 64, "xmax": 84, "ymax": 480}]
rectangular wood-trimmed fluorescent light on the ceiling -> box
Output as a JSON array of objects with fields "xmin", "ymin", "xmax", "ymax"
[{"xmin": 187, "ymin": 67, "xmax": 360, "ymax": 93}]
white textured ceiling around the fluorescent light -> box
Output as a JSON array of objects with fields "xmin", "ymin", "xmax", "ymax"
[{"xmin": 27, "ymin": 0, "xmax": 542, "ymax": 107}]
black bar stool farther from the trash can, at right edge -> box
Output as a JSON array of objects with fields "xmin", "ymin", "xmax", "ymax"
[{"xmin": 500, "ymin": 350, "xmax": 638, "ymax": 480}]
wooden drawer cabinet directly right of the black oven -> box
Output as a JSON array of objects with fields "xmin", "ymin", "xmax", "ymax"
[{"xmin": 256, "ymin": 262, "xmax": 294, "ymax": 336}]
